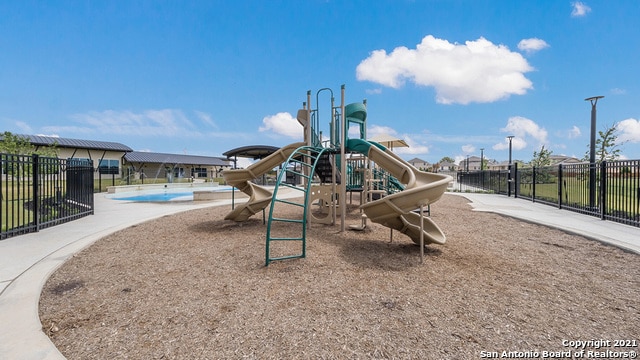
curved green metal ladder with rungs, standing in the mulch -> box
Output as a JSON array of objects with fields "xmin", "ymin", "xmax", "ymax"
[{"xmin": 265, "ymin": 146, "xmax": 328, "ymax": 266}]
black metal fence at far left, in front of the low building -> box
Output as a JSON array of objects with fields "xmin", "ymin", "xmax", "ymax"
[{"xmin": 0, "ymin": 154, "xmax": 94, "ymax": 239}]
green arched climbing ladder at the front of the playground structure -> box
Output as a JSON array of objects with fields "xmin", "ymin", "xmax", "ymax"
[{"xmin": 265, "ymin": 146, "xmax": 325, "ymax": 266}]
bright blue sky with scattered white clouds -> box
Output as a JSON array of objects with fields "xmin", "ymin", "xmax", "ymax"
[{"xmin": 0, "ymin": 0, "xmax": 640, "ymax": 166}]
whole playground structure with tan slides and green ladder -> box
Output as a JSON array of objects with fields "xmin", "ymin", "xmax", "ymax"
[{"xmin": 222, "ymin": 85, "xmax": 452, "ymax": 265}]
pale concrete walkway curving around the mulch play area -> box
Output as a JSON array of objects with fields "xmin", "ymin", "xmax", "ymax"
[{"xmin": 0, "ymin": 193, "xmax": 640, "ymax": 360}]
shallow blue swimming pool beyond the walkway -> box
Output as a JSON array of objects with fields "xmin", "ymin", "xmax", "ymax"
[{"xmin": 107, "ymin": 186, "xmax": 232, "ymax": 202}]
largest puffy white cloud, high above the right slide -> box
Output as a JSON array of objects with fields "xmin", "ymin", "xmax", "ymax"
[{"xmin": 356, "ymin": 35, "xmax": 533, "ymax": 104}]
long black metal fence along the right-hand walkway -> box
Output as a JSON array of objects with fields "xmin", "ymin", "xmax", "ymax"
[{"xmin": 457, "ymin": 160, "xmax": 640, "ymax": 227}]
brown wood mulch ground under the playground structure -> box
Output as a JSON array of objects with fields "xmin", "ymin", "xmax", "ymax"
[{"xmin": 40, "ymin": 194, "xmax": 640, "ymax": 359}]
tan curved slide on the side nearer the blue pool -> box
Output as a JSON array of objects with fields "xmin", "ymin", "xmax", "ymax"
[{"xmin": 222, "ymin": 142, "xmax": 304, "ymax": 222}]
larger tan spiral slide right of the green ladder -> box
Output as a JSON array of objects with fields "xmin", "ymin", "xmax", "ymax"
[{"xmin": 361, "ymin": 146, "xmax": 453, "ymax": 245}]
